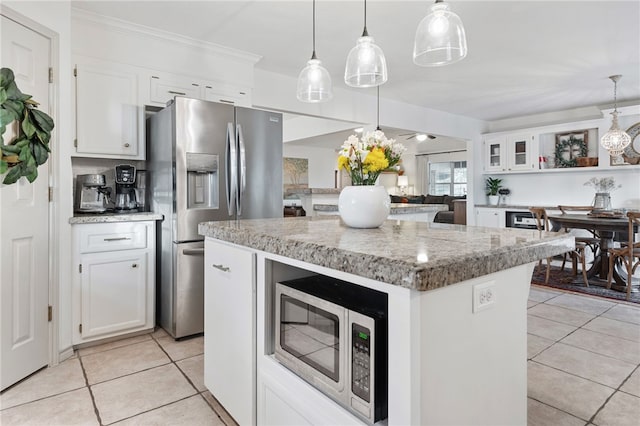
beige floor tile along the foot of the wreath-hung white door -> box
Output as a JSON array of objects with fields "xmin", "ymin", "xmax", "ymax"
[{"xmin": 0, "ymin": 358, "xmax": 86, "ymax": 410}]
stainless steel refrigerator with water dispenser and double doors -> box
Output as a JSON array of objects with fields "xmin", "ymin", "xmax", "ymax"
[{"xmin": 147, "ymin": 97, "xmax": 283, "ymax": 339}]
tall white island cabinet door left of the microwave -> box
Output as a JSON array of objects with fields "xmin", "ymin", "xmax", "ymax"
[{"xmin": 204, "ymin": 239, "xmax": 256, "ymax": 425}]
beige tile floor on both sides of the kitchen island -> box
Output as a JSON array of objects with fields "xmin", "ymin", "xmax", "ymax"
[{"xmin": 0, "ymin": 286, "xmax": 640, "ymax": 426}]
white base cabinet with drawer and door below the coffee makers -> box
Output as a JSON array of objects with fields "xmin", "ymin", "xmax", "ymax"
[{"xmin": 73, "ymin": 221, "xmax": 155, "ymax": 344}]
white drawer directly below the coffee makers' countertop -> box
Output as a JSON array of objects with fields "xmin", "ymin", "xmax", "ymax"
[{"xmin": 77, "ymin": 222, "xmax": 148, "ymax": 253}]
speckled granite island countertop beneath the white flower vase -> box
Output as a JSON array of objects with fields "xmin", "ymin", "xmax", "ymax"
[{"xmin": 198, "ymin": 216, "xmax": 575, "ymax": 291}]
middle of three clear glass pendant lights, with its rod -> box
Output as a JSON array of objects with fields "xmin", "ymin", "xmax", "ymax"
[{"xmin": 344, "ymin": 0, "xmax": 387, "ymax": 87}]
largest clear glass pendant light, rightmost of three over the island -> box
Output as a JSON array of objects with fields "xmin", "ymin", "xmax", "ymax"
[{"xmin": 413, "ymin": 0, "xmax": 467, "ymax": 67}]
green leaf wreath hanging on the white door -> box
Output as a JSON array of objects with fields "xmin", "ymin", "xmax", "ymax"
[{"xmin": 0, "ymin": 68, "xmax": 54, "ymax": 185}]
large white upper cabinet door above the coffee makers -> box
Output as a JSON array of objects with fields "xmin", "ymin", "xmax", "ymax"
[{"xmin": 75, "ymin": 63, "xmax": 144, "ymax": 159}]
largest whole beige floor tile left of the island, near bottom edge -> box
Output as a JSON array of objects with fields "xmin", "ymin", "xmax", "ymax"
[{"xmin": 91, "ymin": 364, "xmax": 196, "ymax": 424}]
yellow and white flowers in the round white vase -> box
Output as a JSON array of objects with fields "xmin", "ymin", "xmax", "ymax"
[{"xmin": 338, "ymin": 130, "xmax": 406, "ymax": 185}]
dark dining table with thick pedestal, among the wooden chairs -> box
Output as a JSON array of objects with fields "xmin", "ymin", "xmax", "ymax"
[{"xmin": 548, "ymin": 213, "xmax": 640, "ymax": 292}]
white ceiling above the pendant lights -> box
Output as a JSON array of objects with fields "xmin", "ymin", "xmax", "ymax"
[{"xmin": 72, "ymin": 0, "xmax": 640, "ymax": 121}]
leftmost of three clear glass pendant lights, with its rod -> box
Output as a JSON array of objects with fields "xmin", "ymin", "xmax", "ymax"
[{"xmin": 296, "ymin": 0, "xmax": 333, "ymax": 103}]
